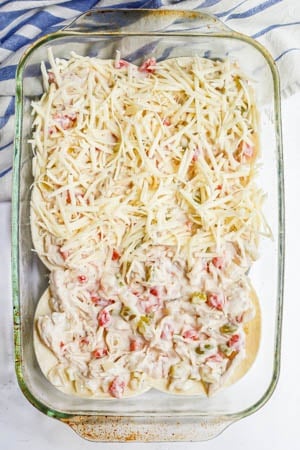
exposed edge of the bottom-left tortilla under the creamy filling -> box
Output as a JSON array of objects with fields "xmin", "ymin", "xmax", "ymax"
[{"xmin": 33, "ymin": 288, "xmax": 151, "ymax": 400}]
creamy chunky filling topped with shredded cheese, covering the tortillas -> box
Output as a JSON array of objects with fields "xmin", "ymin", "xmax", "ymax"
[{"xmin": 31, "ymin": 52, "xmax": 270, "ymax": 398}]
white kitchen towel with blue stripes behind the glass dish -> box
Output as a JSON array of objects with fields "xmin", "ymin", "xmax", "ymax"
[{"xmin": 0, "ymin": 0, "xmax": 300, "ymax": 201}]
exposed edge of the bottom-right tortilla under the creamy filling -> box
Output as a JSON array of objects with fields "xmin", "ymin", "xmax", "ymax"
[{"xmin": 152, "ymin": 287, "xmax": 261, "ymax": 397}]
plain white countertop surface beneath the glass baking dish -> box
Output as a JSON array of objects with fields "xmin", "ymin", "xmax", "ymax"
[{"xmin": 0, "ymin": 94, "xmax": 300, "ymax": 450}]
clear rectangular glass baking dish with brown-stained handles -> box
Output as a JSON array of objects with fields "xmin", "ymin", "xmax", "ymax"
[{"xmin": 12, "ymin": 10, "xmax": 284, "ymax": 441}]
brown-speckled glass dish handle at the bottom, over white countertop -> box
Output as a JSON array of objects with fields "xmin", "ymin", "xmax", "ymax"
[{"xmin": 60, "ymin": 416, "xmax": 233, "ymax": 442}]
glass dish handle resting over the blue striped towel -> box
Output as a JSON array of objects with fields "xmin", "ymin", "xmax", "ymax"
[{"xmin": 63, "ymin": 7, "xmax": 232, "ymax": 34}]
